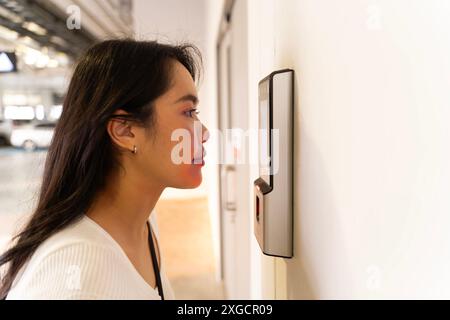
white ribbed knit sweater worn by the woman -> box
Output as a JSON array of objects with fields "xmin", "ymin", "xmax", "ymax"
[{"xmin": 7, "ymin": 212, "xmax": 175, "ymax": 300}]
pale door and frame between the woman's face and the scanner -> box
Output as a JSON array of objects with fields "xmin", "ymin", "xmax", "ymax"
[{"xmin": 217, "ymin": 0, "xmax": 252, "ymax": 299}]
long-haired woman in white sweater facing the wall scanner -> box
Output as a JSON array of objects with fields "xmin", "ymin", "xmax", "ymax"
[{"xmin": 0, "ymin": 40, "xmax": 208, "ymax": 299}]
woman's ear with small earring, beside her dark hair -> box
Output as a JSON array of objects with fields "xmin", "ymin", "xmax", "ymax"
[{"xmin": 106, "ymin": 110, "xmax": 136, "ymax": 151}]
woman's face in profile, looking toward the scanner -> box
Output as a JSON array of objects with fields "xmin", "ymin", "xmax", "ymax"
[{"xmin": 136, "ymin": 61, "xmax": 209, "ymax": 189}]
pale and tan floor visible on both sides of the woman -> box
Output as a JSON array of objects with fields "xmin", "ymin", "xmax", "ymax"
[{"xmin": 0, "ymin": 147, "xmax": 224, "ymax": 300}]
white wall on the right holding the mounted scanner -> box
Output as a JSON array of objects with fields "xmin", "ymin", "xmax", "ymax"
[{"xmin": 246, "ymin": 0, "xmax": 450, "ymax": 299}]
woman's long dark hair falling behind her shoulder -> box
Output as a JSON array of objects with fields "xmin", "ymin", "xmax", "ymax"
[{"xmin": 0, "ymin": 39, "xmax": 201, "ymax": 299}]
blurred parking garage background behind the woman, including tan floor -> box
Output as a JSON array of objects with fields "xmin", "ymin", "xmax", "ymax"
[{"xmin": 0, "ymin": 0, "xmax": 224, "ymax": 299}]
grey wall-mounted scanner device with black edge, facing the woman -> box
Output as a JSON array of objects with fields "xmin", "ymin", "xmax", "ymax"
[{"xmin": 254, "ymin": 69, "xmax": 294, "ymax": 258}]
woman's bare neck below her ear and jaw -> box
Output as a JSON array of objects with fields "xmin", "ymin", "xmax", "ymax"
[{"xmin": 86, "ymin": 168, "xmax": 164, "ymax": 242}]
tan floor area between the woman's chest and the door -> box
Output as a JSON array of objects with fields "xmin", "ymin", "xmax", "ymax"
[{"xmin": 155, "ymin": 198, "xmax": 224, "ymax": 300}]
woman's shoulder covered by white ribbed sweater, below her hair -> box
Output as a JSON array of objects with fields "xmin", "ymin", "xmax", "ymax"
[{"xmin": 8, "ymin": 218, "xmax": 134, "ymax": 299}]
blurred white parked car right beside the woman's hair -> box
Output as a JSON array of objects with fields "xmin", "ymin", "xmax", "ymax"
[{"xmin": 10, "ymin": 122, "xmax": 56, "ymax": 151}]
